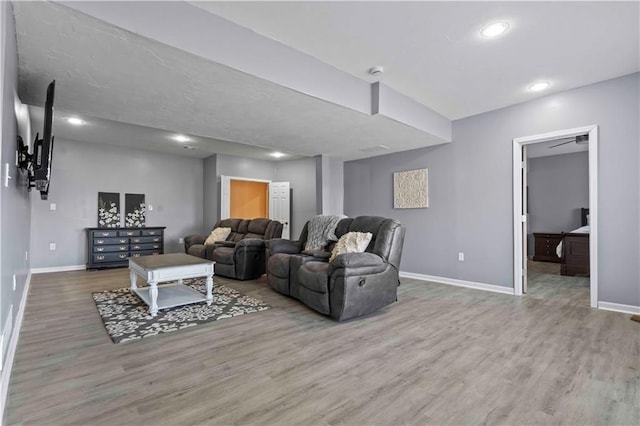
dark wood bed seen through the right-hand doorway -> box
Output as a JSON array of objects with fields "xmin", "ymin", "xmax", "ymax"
[{"xmin": 556, "ymin": 208, "xmax": 591, "ymax": 276}]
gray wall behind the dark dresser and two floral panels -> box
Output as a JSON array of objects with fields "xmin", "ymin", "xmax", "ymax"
[{"xmin": 31, "ymin": 140, "xmax": 203, "ymax": 268}]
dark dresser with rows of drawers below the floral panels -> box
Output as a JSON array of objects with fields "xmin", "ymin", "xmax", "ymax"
[{"xmin": 87, "ymin": 226, "xmax": 166, "ymax": 269}]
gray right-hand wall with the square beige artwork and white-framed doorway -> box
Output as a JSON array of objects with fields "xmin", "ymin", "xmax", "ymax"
[{"xmin": 344, "ymin": 73, "xmax": 640, "ymax": 306}]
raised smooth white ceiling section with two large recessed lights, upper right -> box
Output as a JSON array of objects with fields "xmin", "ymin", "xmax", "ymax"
[{"xmin": 193, "ymin": 1, "xmax": 640, "ymax": 119}]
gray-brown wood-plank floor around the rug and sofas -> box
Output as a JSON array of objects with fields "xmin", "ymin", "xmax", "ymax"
[{"xmin": 5, "ymin": 269, "xmax": 640, "ymax": 425}]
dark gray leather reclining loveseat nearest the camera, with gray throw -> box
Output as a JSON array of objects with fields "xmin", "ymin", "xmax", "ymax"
[{"xmin": 267, "ymin": 216, "xmax": 405, "ymax": 321}]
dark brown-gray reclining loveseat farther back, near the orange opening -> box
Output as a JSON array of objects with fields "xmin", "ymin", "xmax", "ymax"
[{"xmin": 184, "ymin": 218, "xmax": 282, "ymax": 280}]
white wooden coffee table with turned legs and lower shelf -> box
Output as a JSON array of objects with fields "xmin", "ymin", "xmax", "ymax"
[{"xmin": 129, "ymin": 253, "xmax": 215, "ymax": 317}]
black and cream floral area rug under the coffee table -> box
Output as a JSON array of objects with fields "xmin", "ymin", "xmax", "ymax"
[{"xmin": 92, "ymin": 278, "xmax": 269, "ymax": 343}]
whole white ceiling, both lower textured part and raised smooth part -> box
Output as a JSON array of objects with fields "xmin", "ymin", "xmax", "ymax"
[{"xmin": 13, "ymin": 2, "xmax": 640, "ymax": 159}]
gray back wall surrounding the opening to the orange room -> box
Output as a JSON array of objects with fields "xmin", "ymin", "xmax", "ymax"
[{"xmin": 202, "ymin": 154, "xmax": 316, "ymax": 239}]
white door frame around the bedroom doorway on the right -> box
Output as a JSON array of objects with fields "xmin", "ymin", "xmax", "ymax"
[{"xmin": 512, "ymin": 124, "xmax": 599, "ymax": 308}]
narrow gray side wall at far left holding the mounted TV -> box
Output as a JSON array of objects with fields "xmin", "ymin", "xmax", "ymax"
[{"xmin": 0, "ymin": 1, "xmax": 31, "ymax": 366}]
